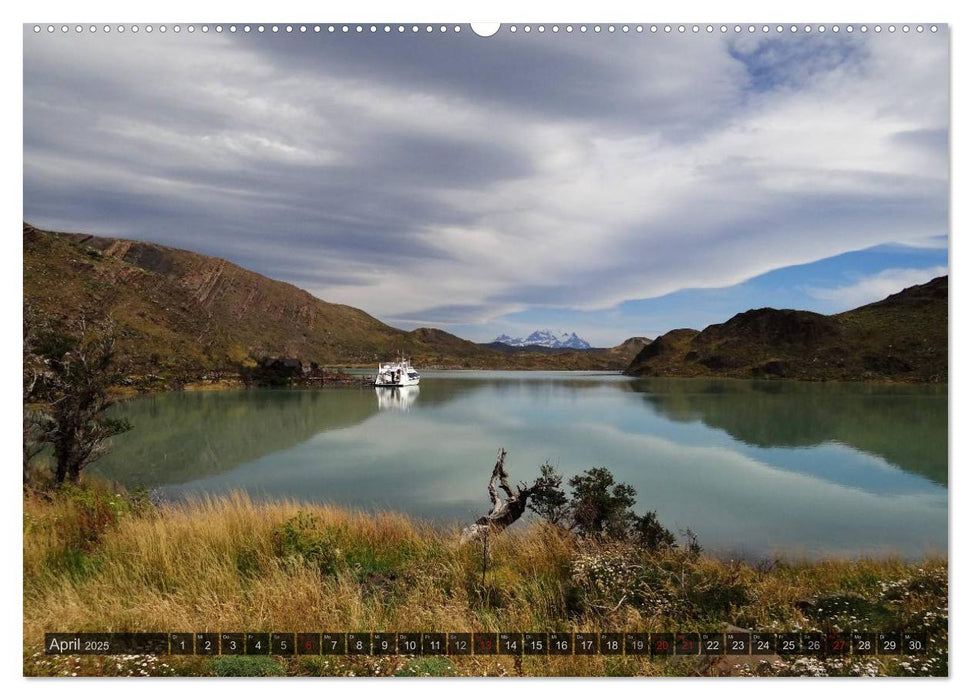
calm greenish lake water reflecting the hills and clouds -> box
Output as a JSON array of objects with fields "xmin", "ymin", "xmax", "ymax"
[{"xmin": 92, "ymin": 371, "xmax": 948, "ymax": 558}]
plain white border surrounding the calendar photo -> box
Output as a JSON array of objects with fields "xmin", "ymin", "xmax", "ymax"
[{"xmin": 0, "ymin": 0, "xmax": 971, "ymax": 700}]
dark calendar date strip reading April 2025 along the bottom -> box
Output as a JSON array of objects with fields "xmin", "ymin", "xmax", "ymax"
[{"xmin": 44, "ymin": 632, "xmax": 927, "ymax": 657}]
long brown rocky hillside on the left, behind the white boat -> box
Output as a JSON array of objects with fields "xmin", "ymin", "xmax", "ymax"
[{"xmin": 23, "ymin": 223, "xmax": 636, "ymax": 378}]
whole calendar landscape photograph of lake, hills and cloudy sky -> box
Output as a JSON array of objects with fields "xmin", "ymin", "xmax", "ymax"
[{"xmin": 22, "ymin": 23, "xmax": 950, "ymax": 678}]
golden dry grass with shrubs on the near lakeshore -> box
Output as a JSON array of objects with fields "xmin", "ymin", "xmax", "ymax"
[{"xmin": 24, "ymin": 487, "xmax": 947, "ymax": 675}]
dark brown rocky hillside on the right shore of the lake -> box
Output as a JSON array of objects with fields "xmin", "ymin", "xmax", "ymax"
[{"xmin": 626, "ymin": 276, "xmax": 948, "ymax": 382}]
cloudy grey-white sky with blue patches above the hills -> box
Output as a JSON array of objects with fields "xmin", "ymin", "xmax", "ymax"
[{"xmin": 24, "ymin": 25, "xmax": 948, "ymax": 345}]
